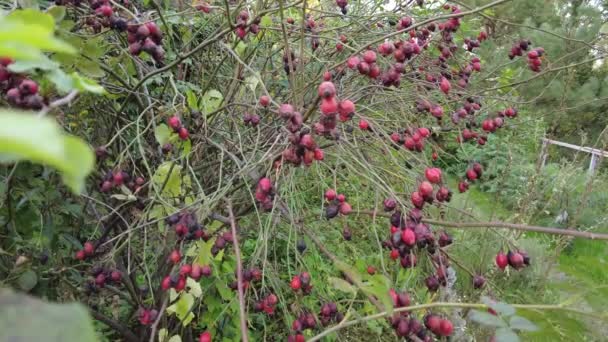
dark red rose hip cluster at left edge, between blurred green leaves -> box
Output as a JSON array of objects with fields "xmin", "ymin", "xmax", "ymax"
[{"xmin": 0, "ymin": 57, "xmax": 44, "ymax": 110}]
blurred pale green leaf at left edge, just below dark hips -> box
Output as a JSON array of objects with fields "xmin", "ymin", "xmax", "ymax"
[{"xmin": 0, "ymin": 110, "xmax": 95, "ymax": 193}]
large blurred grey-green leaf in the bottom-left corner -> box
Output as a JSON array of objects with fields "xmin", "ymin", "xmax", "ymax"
[{"xmin": 0, "ymin": 289, "xmax": 97, "ymax": 342}]
